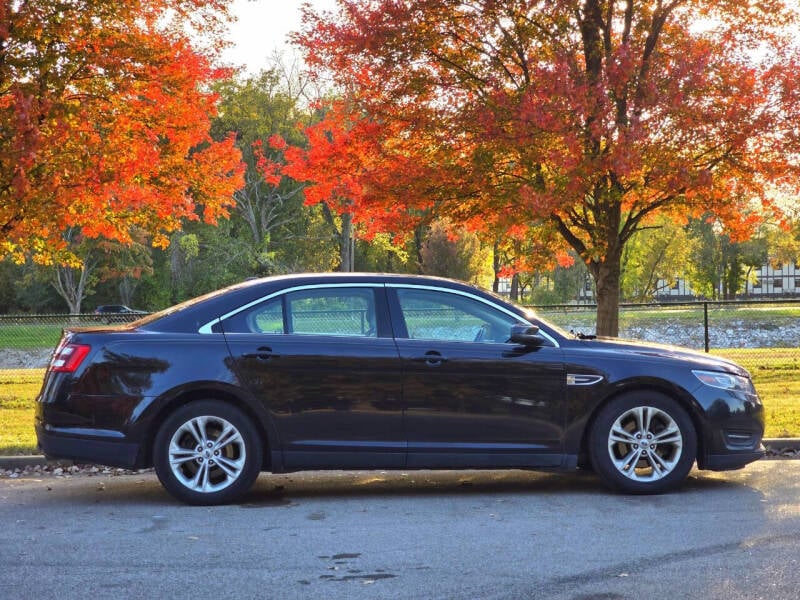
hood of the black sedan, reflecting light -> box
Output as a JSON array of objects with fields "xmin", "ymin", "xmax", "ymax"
[{"xmin": 578, "ymin": 337, "xmax": 750, "ymax": 377}]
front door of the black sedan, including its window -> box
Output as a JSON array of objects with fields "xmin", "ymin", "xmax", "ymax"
[{"xmin": 389, "ymin": 286, "xmax": 566, "ymax": 468}]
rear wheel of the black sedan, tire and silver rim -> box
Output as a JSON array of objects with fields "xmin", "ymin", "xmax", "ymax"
[{"xmin": 153, "ymin": 400, "xmax": 262, "ymax": 505}]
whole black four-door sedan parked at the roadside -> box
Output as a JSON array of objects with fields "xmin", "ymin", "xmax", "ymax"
[{"xmin": 36, "ymin": 274, "xmax": 764, "ymax": 504}]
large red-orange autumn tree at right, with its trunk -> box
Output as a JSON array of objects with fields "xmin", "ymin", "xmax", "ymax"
[{"xmin": 295, "ymin": 0, "xmax": 800, "ymax": 335}]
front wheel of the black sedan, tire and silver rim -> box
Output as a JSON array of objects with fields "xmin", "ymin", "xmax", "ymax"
[{"xmin": 589, "ymin": 391, "xmax": 697, "ymax": 494}]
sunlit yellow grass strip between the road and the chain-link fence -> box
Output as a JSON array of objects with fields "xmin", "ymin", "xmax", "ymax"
[{"xmin": 0, "ymin": 348, "xmax": 800, "ymax": 455}]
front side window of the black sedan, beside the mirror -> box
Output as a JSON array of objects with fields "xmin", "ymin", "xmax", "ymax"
[{"xmin": 397, "ymin": 288, "xmax": 520, "ymax": 343}]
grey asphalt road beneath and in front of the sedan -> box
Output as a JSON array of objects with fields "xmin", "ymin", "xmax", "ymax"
[{"xmin": 0, "ymin": 460, "xmax": 800, "ymax": 600}]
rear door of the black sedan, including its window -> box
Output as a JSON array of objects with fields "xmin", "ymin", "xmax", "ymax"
[{"xmin": 222, "ymin": 284, "xmax": 406, "ymax": 469}]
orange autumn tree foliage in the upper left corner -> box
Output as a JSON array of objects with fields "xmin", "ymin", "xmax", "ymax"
[{"xmin": 0, "ymin": 0, "xmax": 243, "ymax": 262}]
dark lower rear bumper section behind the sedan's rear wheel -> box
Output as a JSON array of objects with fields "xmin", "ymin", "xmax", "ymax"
[{"xmin": 36, "ymin": 424, "xmax": 139, "ymax": 469}]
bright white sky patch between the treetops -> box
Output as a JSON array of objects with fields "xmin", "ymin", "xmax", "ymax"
[{"xmin": 223, "ymin": 0, "xmax": 336, "ymax": 73}]
